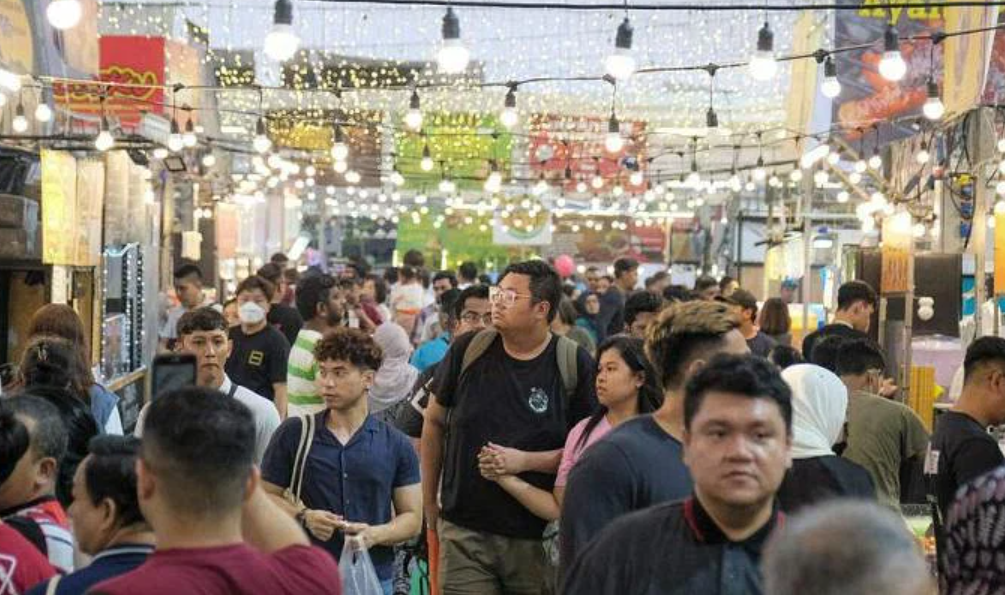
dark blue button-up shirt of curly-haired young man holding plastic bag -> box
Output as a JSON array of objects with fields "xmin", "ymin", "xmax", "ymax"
[{"xmin": 261, "ymin": 409, "xmax": 420, "ymax": 581}]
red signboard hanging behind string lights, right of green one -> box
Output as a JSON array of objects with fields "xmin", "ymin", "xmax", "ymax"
[{"xmin": 529, "ymin": 114, "xmax": 648, "ymax": 193}]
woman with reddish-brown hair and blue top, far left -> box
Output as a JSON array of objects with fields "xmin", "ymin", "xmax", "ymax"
[{"xmin": 28, "ymin": 304, "xmax": 123, "ymax": 435}]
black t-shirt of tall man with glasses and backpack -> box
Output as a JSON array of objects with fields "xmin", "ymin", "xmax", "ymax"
[{"xmin": 433, "ymin": 334, "xmax": 597, "ymax": 539}]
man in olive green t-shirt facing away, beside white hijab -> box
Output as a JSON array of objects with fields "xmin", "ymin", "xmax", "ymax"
[{"xmin": 835, "ymin": 339, "xmax": 929, "ymax": 511}]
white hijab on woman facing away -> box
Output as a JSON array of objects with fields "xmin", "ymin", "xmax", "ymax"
[{"xmin": 782, "ymin": 364, "xmax": 848, "ymax": 458}]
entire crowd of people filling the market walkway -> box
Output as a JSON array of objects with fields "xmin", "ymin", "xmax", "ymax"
[{"xmin": 0, "ymin": 251, "xmax": 1005, "ymax": 595}]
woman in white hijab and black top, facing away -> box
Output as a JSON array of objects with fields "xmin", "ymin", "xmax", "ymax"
[{"xmin": 778, "ymin": 364, "xmax": 875, "ymax": 513}]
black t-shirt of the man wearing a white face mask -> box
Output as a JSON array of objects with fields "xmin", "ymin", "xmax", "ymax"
[{"xmin": 224, "ymin": 325, "xmax": 289, "ymax": 401}]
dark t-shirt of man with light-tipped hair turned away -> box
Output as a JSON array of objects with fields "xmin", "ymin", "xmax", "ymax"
[{"xmin": 559, "ymin": 415, "xmax": 691, "ymax": 582}]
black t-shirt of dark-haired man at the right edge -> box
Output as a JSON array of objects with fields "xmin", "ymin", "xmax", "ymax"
[{"xmin": 925, "ymin": 411, "xmax": 1005, "ymax": 519}]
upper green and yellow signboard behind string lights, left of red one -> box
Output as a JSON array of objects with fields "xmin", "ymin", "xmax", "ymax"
[{"xmin": 393, "ymin": 113, "xmax": 513, "ymax": 192}]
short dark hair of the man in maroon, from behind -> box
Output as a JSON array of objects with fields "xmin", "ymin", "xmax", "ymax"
[{"xmin": 140, "ymin": 387, "xmax": 255, "ymax": 517}]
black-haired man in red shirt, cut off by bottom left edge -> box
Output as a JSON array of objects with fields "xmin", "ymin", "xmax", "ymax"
[{"xmin": 0, "ymin": 405, "xmax": 56, "ymax": 595}]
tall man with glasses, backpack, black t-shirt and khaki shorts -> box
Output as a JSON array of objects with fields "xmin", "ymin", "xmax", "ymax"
[{"xmin": 421, "ymin": 261, "xmax": 596, "ymax": 595}]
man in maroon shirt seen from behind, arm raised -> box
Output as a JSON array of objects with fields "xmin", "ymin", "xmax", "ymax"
[{"xmin": 89, "ymin": 388, "xmax": 342, "ymax": 595}]
